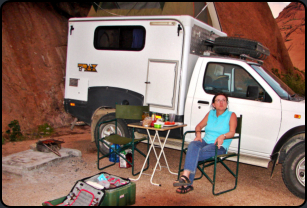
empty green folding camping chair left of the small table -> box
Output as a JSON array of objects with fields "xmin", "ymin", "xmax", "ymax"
[{"xmin": 96, "ymin": 105, "xmax": 149, "ymax": 176}]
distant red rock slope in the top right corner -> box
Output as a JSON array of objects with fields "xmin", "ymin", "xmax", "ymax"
[{"xmin": 276, "ymin": 2, "xmax": 305, "ymax": 71}]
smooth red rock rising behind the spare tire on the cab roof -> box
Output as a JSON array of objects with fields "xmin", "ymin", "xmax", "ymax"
[{"xmin": 215, "ymin": 2, "xmax": 293, "ymax": 75}]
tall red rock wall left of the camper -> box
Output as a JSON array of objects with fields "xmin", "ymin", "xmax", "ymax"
[{"xmin": 2, "ymin": 2, "xmax": 89, "ymax": 132}]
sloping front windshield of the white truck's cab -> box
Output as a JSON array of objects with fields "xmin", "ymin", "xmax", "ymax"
[{"xmin": 251, "ymin": 64, "xmax": 295, "ymax": 100}]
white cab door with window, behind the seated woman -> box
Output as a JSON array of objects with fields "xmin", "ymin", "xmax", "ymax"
[{"xmin": 190, "ymin": 61, "xmax": 281, "ymax": 160}]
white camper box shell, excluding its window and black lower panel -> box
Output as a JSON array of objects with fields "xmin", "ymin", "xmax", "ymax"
[{"xmin": 65, "ymin": 16, "xmax": 226, "ymax": 115}]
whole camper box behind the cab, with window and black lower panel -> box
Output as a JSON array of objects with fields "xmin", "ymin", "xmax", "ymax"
[{"xmin": 65, "ymin": 16, "xmax": 226, "ymax": 124}]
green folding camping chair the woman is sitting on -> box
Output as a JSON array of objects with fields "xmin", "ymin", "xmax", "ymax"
[{"xmin": 177, "ymin": 115, "xmax": 242, "ymax": 195}]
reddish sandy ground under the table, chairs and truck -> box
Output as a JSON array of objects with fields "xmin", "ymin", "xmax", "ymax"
[{"xmin": 2, "ymin": 126, "xmax": 304, "ymax": 206}]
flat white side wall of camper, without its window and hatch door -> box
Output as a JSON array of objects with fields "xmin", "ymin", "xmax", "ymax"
[{"xmin": 65, "ymin": 18, "xmax": 183, "ymax": 112}]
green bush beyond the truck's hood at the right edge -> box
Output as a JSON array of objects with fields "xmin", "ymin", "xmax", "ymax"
[{"xmin": 272, "ymin": 67, "xmax": 305, "ymax": 97}]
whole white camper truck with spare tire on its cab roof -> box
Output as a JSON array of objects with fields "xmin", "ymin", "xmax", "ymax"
[{"xmin": 64, "ymin": 16, "xmax": 305, "ymax": 198}]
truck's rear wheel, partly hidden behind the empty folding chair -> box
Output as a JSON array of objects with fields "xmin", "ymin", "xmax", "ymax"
[{"xmin": 94, "ymin": 113, "xmax": 131, "ymax": 155}]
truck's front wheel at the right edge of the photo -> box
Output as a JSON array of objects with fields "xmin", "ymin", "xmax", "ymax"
[{"xmin": 282, "ymin": 142, "xmax": 305, "ymax": 199}]
